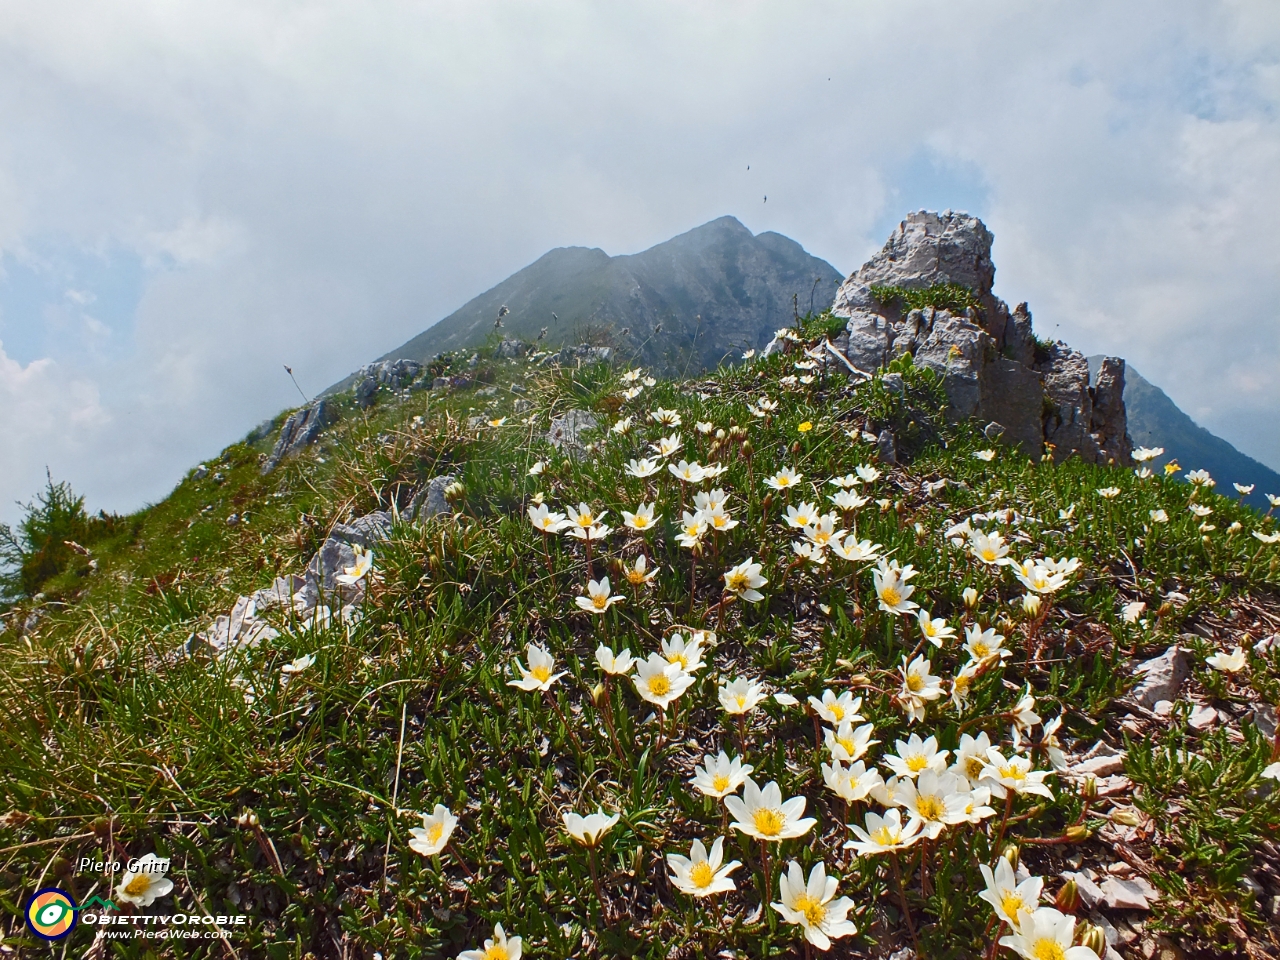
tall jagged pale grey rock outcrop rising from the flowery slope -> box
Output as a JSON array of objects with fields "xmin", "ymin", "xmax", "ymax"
[{"xmin": 832, "ymin": 210, "xmax": 1130, "ymax": 463}]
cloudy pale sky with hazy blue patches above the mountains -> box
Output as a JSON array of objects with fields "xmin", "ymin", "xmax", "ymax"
[{"xmin": 0, "ymin": 0, "xmax": 1280, "ymax": 522}]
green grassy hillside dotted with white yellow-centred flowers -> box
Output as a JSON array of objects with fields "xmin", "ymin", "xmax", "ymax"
[{"xmin": 0, "ymin": 317, "xmax": 1280, "ymax": 960}]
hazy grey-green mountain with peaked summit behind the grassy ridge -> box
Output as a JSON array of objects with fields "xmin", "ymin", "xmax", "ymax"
[{"xmin": 366, "ymin": 216, "xmax": 844, "ymax": 372}]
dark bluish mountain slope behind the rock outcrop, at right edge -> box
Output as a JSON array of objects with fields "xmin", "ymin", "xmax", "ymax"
[{"xmin": 1089, "ymin": 357, "xmax": 1280, "ymax": 509}]
